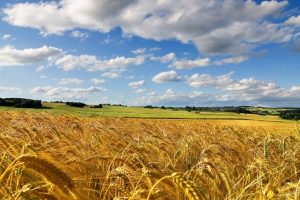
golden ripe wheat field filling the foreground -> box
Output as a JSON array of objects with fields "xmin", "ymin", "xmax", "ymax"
[{"xmin": 0, "ymin": 112, "xmax": 300, "ymax": 200}]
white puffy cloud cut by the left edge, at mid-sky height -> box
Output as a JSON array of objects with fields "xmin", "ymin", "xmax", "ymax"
[{"xmin": 0, "ymin": 46, "xmax": 62, "ymax": 67}]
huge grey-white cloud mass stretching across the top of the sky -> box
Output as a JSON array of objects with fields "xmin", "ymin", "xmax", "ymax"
[{"xmin": 3, "ymin": 0, "xmax": 292, "ymax": 54}]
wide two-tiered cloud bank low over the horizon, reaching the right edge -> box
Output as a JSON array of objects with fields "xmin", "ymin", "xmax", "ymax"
[{"xmin": 136, "ymin": 72, "xmax": 300, "ymax": 106}]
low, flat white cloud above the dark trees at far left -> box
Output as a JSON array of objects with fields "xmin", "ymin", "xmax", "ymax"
[{"xmin": 31, "ymin": 86, "xmax": 107, "ymax": 99}]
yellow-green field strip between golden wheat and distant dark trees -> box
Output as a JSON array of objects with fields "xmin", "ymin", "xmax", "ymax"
[{"xmin": 0, "ymin": 102, "xmax": 292, "ymax": 122}]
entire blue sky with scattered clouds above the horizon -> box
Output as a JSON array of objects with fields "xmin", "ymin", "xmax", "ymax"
[{"xmin": 0, "ymin": 0, "xmax": 300, "ymax": 107}]
